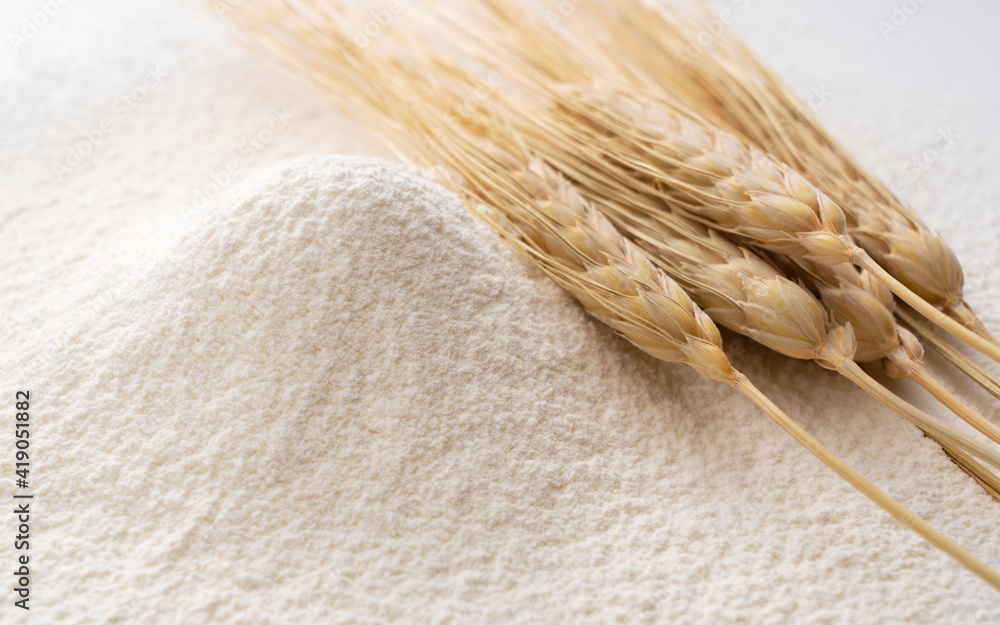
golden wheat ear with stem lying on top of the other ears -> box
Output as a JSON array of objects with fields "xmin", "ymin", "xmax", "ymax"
[{"xmin": 524, "ymin": 91, "xmax": 1000, "ymax": 361}]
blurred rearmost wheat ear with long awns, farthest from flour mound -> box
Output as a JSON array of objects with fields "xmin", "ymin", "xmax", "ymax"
[{"xmin": 570, "ymin": 0, "xmax": 997, "ymax": 343}]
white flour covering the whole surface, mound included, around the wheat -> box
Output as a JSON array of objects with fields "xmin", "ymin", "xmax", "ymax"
[{"xmin": 0, "ymin": 0, "xmax": 1000, "ymax": 624}]
